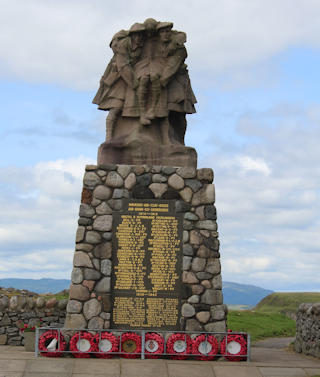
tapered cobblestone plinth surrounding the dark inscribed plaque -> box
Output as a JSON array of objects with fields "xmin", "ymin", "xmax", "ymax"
[{"xmin": 65, "ymin": 165, "xmax": 227, "ymax": 331}]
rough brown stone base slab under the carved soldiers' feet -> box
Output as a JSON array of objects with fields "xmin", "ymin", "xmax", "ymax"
[{"xmin": 98, "ymin": 140, "xmax": 197, "ymax": 168}]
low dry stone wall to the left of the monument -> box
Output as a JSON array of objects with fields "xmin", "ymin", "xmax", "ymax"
[{"xmin": 0, "ymin": 295, "xmax": 67, "ymax": 346}]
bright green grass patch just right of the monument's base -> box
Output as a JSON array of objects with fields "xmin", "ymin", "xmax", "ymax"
[{"xmin": 228, "ymin": 310, "xmax": 296, "ymax": 341}]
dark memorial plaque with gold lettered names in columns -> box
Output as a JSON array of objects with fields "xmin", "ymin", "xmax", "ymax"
[{"xmin": 112, "ymin": 200, "xmax": 182, "ymax": 330}]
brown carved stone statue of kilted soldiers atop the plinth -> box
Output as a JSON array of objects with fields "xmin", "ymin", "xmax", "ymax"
[{"xmin": 93, "ymin": 18, "xmax": 197, "ymax": 167}]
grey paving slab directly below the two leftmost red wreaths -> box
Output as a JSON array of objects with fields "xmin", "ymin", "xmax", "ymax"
[{"xmin": 25, "ymin": 358, "xmax": 74, "ymax": 377}]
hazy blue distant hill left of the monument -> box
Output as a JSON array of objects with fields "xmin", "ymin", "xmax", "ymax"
[{"xmin": 0, "ymin": 278, "xmax": 70, "ymax": 293}]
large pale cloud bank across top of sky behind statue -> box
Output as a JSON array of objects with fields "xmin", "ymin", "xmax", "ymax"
[{"xmin": 0, "ymin": 0, "xmax": 320, "ymax": 89}]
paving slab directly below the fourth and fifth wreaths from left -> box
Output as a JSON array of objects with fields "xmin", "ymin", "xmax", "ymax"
[{"xmin": 121, "ymin": 359, "xmax": 168, "ymax": 377}]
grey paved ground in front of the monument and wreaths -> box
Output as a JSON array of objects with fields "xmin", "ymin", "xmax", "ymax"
[{"xmin": 0, "ymin": 339, "xmax": 320, "ymax": 377}]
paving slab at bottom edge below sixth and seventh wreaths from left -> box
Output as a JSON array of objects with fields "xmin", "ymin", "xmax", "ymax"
[{"xmin": 168, "ymin": 361, "xmax": 215, "ymax": 377}]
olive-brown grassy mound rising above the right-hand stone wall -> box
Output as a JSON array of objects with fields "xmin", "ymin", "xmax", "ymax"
[{"xmin": 255, "ymin": 292, "xmax": 320, "ymax": 313}]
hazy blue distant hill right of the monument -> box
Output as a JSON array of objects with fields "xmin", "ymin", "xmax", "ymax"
[{"xmin": 222, "ymin": 281, "xmax": 273, "ymax": 307}]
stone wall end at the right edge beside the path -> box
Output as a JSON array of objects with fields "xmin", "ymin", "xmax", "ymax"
[{"xmin": 294, "ymin": 302, "xmax": 320, "ymax": 358}]
